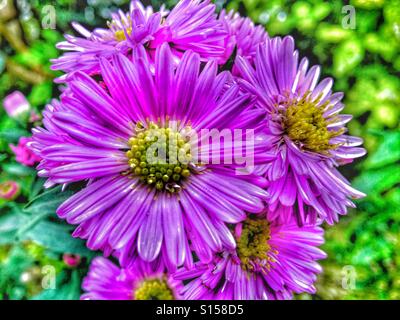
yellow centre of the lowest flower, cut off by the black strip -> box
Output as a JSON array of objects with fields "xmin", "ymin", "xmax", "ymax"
[{"xmin": 134, "ymin": 279, "xmax": 174, "ymax": 300}]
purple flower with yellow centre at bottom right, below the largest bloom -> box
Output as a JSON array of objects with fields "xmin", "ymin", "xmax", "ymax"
[{"xmin": 174, "ymin": 212, "xmax": 326, "ymax": 300}]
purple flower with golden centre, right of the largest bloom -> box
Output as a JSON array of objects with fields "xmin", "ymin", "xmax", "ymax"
[{"xmin": 236, "ymin": 37, "xmax": 365, "ymax": 224}]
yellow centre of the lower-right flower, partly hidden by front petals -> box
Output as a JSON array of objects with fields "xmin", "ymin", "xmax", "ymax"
[{"xmin": 236, "ymin": 217, "xmax": 273, "ymax": 271}]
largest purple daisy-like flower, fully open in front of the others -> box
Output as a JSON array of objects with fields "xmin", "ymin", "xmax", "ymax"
[{"xmin": 31, "ymin": 44, "xmax": 267, "ymax": 269}]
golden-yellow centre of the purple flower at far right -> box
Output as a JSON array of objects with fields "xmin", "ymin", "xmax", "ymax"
[{"xmin": 283, "ymin": 93, "xmax": 343, "ymax": 154}]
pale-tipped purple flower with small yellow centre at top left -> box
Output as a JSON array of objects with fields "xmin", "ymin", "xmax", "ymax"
[{"xmin": 52, "ymin": 0, "xmax": 162, "ymax": 80}]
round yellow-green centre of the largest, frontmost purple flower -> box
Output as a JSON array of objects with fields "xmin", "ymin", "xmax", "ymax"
[{"xmin": 126, "ymin": 122, "xmax": 192, "ymax": 193}]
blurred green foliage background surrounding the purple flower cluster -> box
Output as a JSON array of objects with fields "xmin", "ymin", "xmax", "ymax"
[{"xmin": 0, "ymin": 0, "xmax": 400, "ymax": 299}]
